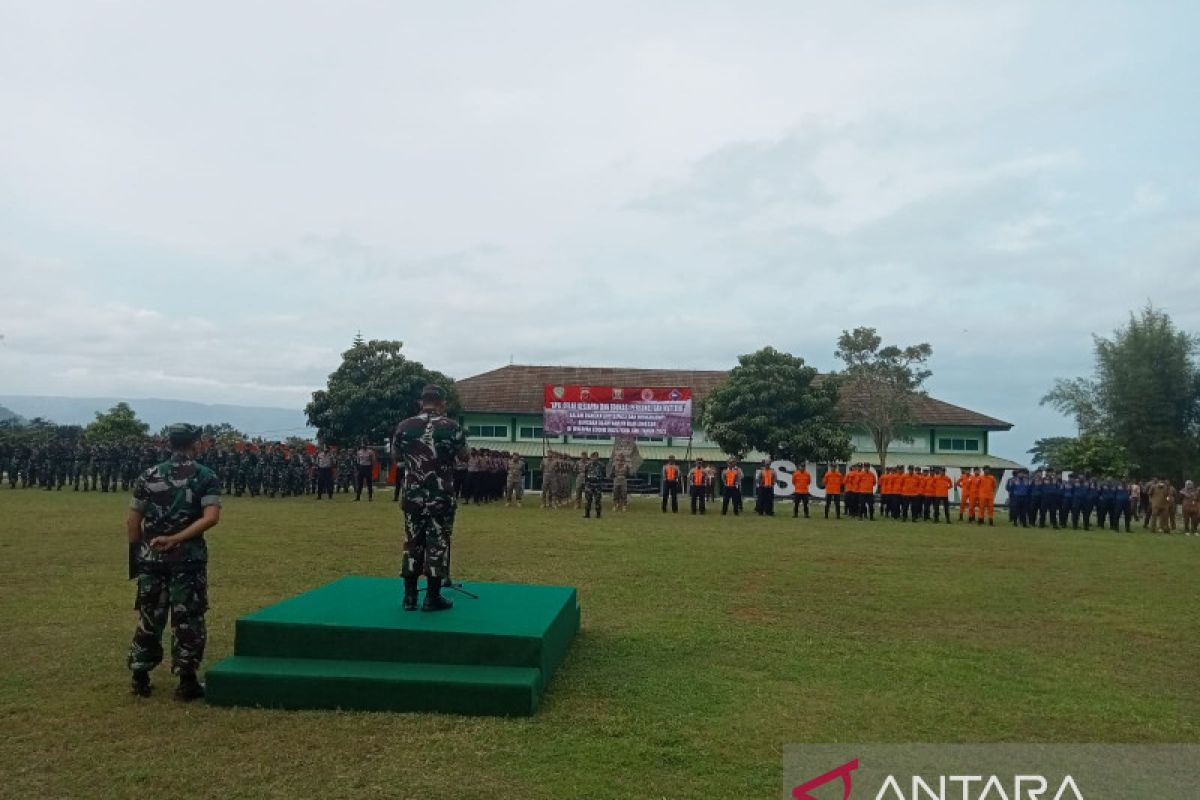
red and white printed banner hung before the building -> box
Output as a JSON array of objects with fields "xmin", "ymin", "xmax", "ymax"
[{"xmin": 542, "ymin": 384, "xmax": 691, "ymax": 437}]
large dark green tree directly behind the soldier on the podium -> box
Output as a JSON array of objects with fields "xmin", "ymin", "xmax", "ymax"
[{"xmin": 305, "ymin": 336, "xmax": 461, "ymax": 446}]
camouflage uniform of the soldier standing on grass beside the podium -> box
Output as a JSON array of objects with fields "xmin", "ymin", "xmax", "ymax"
[{"xmin": 128, "ymin": 455, "xmax": 221, "ymax": 674}]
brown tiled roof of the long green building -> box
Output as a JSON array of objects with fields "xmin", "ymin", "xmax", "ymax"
[{"xmin": 455, "ymin": 365, "xmax": 1013, "ymax": 431}]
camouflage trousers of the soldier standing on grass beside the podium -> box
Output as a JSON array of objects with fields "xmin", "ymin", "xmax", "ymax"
[{"xmin": 128, "ymin": 564, "xmax": 209, "ymax": 675}]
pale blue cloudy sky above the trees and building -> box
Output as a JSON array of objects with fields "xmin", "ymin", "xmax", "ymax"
[{"xmin": 0, "ymin": 0, "xmax": 1200, "ymax": 461}]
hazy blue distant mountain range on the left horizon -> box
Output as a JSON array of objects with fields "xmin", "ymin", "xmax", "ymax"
[{"xmin": 0, "ymin": 395, "xmax": 316, "ymax": 439}]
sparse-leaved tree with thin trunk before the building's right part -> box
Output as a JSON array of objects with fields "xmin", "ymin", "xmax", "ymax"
[{"xmin": 835, "ymin": 327, "xmax": 934, "ymax": 467}]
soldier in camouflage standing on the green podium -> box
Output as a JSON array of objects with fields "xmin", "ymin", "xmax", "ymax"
[{"xmin": 392, "ymin": 385, "xmax": 468, "ymax": 612}]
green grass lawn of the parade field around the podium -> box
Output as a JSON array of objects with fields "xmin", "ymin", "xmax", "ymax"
[{"xmin": 0, "ymin": 489, "xmax": 1200, "ymax": 800}]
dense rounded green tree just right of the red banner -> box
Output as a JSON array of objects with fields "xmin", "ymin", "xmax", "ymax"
[{"xmin": 700, "ymin": 347, "xmax": 852, "ymax": 462}]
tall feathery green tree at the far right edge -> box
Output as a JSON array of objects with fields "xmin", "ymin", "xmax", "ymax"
[{"xmin": 1042, "ymin": 306, "xmax": 1200, "ymax": 480}]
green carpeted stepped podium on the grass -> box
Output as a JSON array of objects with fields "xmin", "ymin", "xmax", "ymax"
[{"xmin": 206, "ymin": 577, "xmax": 580, "ymax": 715}]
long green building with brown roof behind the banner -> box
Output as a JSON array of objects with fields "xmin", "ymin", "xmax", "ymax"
[{"xmin": 456, "ymin": 365, "xmax": 1021, "ymax": 488}]
